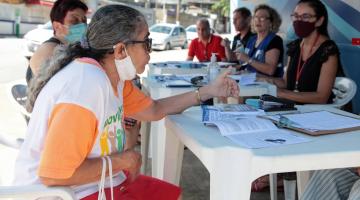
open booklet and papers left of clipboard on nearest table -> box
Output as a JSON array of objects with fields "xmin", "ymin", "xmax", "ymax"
[{"xmin": 202, "ymin": 105, "xmax": 311, "ymax": 148}]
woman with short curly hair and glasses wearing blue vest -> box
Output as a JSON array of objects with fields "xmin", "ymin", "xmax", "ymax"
[{"xmin": 236, "ymin": 4, "xmax": 284, "ymax": 77}]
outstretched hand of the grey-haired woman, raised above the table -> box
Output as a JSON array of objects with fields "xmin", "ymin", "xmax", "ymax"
[{"xmin": 209, "ymin": 67, "xmax": 240, "ymax": 97}]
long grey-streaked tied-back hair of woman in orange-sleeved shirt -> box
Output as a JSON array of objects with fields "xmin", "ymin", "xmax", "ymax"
[{"xmin": 26, "ymin": 5, "xmax": 147, "ymax": 112}]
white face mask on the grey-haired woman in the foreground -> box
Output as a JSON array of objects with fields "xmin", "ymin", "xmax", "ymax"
[{"xmin": 115, "ymin": 49, "xmax": 136, "ymax": 81}]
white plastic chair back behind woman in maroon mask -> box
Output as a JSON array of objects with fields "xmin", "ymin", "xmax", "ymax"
[{"xmin": 331, "ymin": 77, "xmax": 357, "ymax": 108}]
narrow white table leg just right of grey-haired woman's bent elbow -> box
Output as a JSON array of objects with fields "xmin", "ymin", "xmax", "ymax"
[{"xmin": 140, "ymin": 121, "xmax": 151, "ymax": 174}]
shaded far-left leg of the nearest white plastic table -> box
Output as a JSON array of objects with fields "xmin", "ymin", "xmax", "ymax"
[{"xmin": 163, "ymin": 126, "xmax": 184, "ymax": 185}]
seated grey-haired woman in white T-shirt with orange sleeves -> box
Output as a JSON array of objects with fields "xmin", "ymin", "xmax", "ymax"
[{"xmin": 15, "ymin": 5, "xmax": 239, "ymax": 200}]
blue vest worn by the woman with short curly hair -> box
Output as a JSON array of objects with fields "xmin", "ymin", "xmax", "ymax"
[{"xmin": 244, "ymin": 33, "xmax": 284, "ymax": 77}]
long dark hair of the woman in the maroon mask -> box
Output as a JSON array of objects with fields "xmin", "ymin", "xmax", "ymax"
[{"xmin": 297, "ymin": 0, "xmax": 329, "ymax": 37}]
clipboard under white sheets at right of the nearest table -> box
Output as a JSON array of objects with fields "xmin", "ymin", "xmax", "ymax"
[{"xmin": 259, "ymin": 110, "xmax": 360, "ymax": 136}]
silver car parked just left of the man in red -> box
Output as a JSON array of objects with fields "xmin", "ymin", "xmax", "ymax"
[{"xmin": 150, "ymin": 23, "xmax": 187, "ymax": 50}]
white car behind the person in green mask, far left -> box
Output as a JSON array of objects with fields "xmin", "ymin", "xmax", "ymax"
[{"xmin": 23, "ymin": 21, "xmax": 54, "ymax": 59}]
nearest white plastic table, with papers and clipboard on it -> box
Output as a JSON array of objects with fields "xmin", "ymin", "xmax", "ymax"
[{"xmin": 163, "ymin": 106, "xmax": 360, "ymax": 200}]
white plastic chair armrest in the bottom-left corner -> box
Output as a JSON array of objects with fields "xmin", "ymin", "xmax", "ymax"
[{"xmin": 0, "ymin": 184, "xmax": 76, "ymax": 200}]
